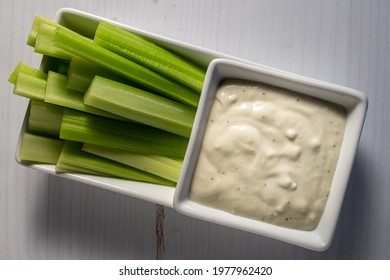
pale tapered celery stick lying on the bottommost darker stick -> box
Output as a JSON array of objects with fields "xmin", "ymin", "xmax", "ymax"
[{"xmin": 83, "ymin": 144, "xmax": 183, "ymax": 182}]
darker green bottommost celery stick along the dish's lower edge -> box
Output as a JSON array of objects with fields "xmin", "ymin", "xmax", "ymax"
[{"xmin": 58, "ymin": 141, "xmax": 174, "ymax": 186}]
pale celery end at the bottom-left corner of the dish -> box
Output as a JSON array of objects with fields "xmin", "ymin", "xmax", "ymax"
[{"xmin": 18, "ymin": 132, "xmax": 64, "ymax": 164}]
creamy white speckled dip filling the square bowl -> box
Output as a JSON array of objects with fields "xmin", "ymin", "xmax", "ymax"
[{"xmin": 190, "ymin": 80, "xmax": 346, "ymax": 230}]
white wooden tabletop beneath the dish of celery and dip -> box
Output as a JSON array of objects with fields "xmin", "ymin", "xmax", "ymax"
[{"xmin": 0, "ymin": 0, "xmax": 390, "ymax": 259}]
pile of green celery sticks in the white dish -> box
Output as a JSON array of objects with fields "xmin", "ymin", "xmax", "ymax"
[{"xmin": 9, "ymin": 15, "xmax": 205, "ymax": 186}]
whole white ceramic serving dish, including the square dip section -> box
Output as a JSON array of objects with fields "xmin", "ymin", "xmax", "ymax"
[{"xmin": 16, "ymin": 8, "xmax": 367, "ymax": 250}]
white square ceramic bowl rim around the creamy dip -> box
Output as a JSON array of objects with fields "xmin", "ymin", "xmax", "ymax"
[{"xmin": 173, "ymin": 59, "xmax": 368, "ymax": 251}]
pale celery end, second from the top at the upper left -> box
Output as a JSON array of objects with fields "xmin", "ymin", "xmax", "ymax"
[{"xmin": 34, "ymin": 23, "xmax": 72, "ymax": 60}]
